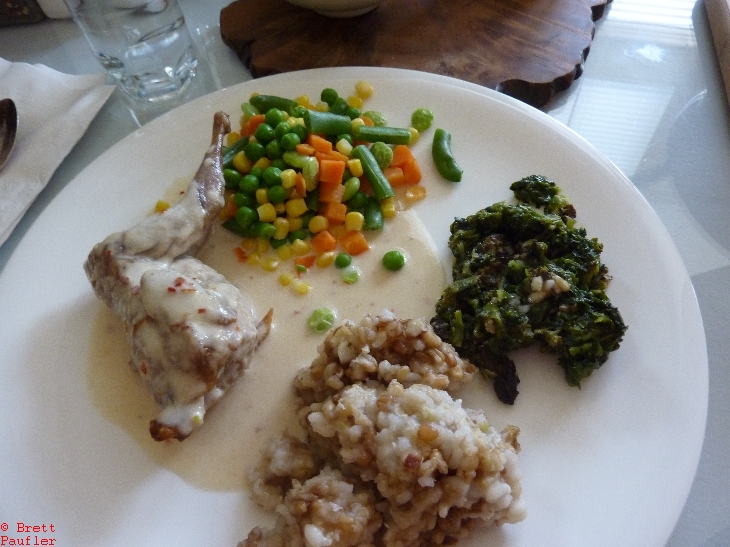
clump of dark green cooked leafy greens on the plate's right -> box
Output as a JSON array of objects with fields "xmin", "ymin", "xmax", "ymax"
[{"xmin": 431, "ymin": 175, "xmax": 627, "ymax": 404}]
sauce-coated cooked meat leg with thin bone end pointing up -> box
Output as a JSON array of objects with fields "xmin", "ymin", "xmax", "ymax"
[{"xmin": 84, "ymin": 112, "xmax": 271, "ymax": 441}]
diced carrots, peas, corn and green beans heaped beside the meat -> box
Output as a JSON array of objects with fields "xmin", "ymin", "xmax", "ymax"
[{"xmin": 213, "ymin": 81, "xmax": 446, "ymax": 294}]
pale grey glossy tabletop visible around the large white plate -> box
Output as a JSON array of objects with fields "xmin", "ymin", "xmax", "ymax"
[{"xmin": 0, "ymin": 0, "xmax": 730, "ymax": 547}]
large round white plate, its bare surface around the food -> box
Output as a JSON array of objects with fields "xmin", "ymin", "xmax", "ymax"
[{"xmin": 0, "ymin": 68, "xmax": 707, "ymax": 547}]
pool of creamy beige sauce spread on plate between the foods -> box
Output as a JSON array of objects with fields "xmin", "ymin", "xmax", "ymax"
[{"xmin": 89, "ymin": 206, "xmax": 446, "ymax": 490}]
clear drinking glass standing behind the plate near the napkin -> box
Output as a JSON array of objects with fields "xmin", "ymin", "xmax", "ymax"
[{"xmin": 64, "ymin": 0, "xmax": 197, "ymax": 102}]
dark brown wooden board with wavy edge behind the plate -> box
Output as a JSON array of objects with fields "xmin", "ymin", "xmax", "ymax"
[{"xmin": 220, "ymin": 0, "xmax": 611, "ymax": 107}]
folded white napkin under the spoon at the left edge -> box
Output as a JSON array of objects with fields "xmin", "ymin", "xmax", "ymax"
[{"xmin": 0, "ymin": 58, "xmax": 114, "ymax": 245}]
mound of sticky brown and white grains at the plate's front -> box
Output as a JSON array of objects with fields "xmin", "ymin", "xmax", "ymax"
[{"xmin": 239, "ymin": 311, "xmax": 525, "ymax": 547}]
